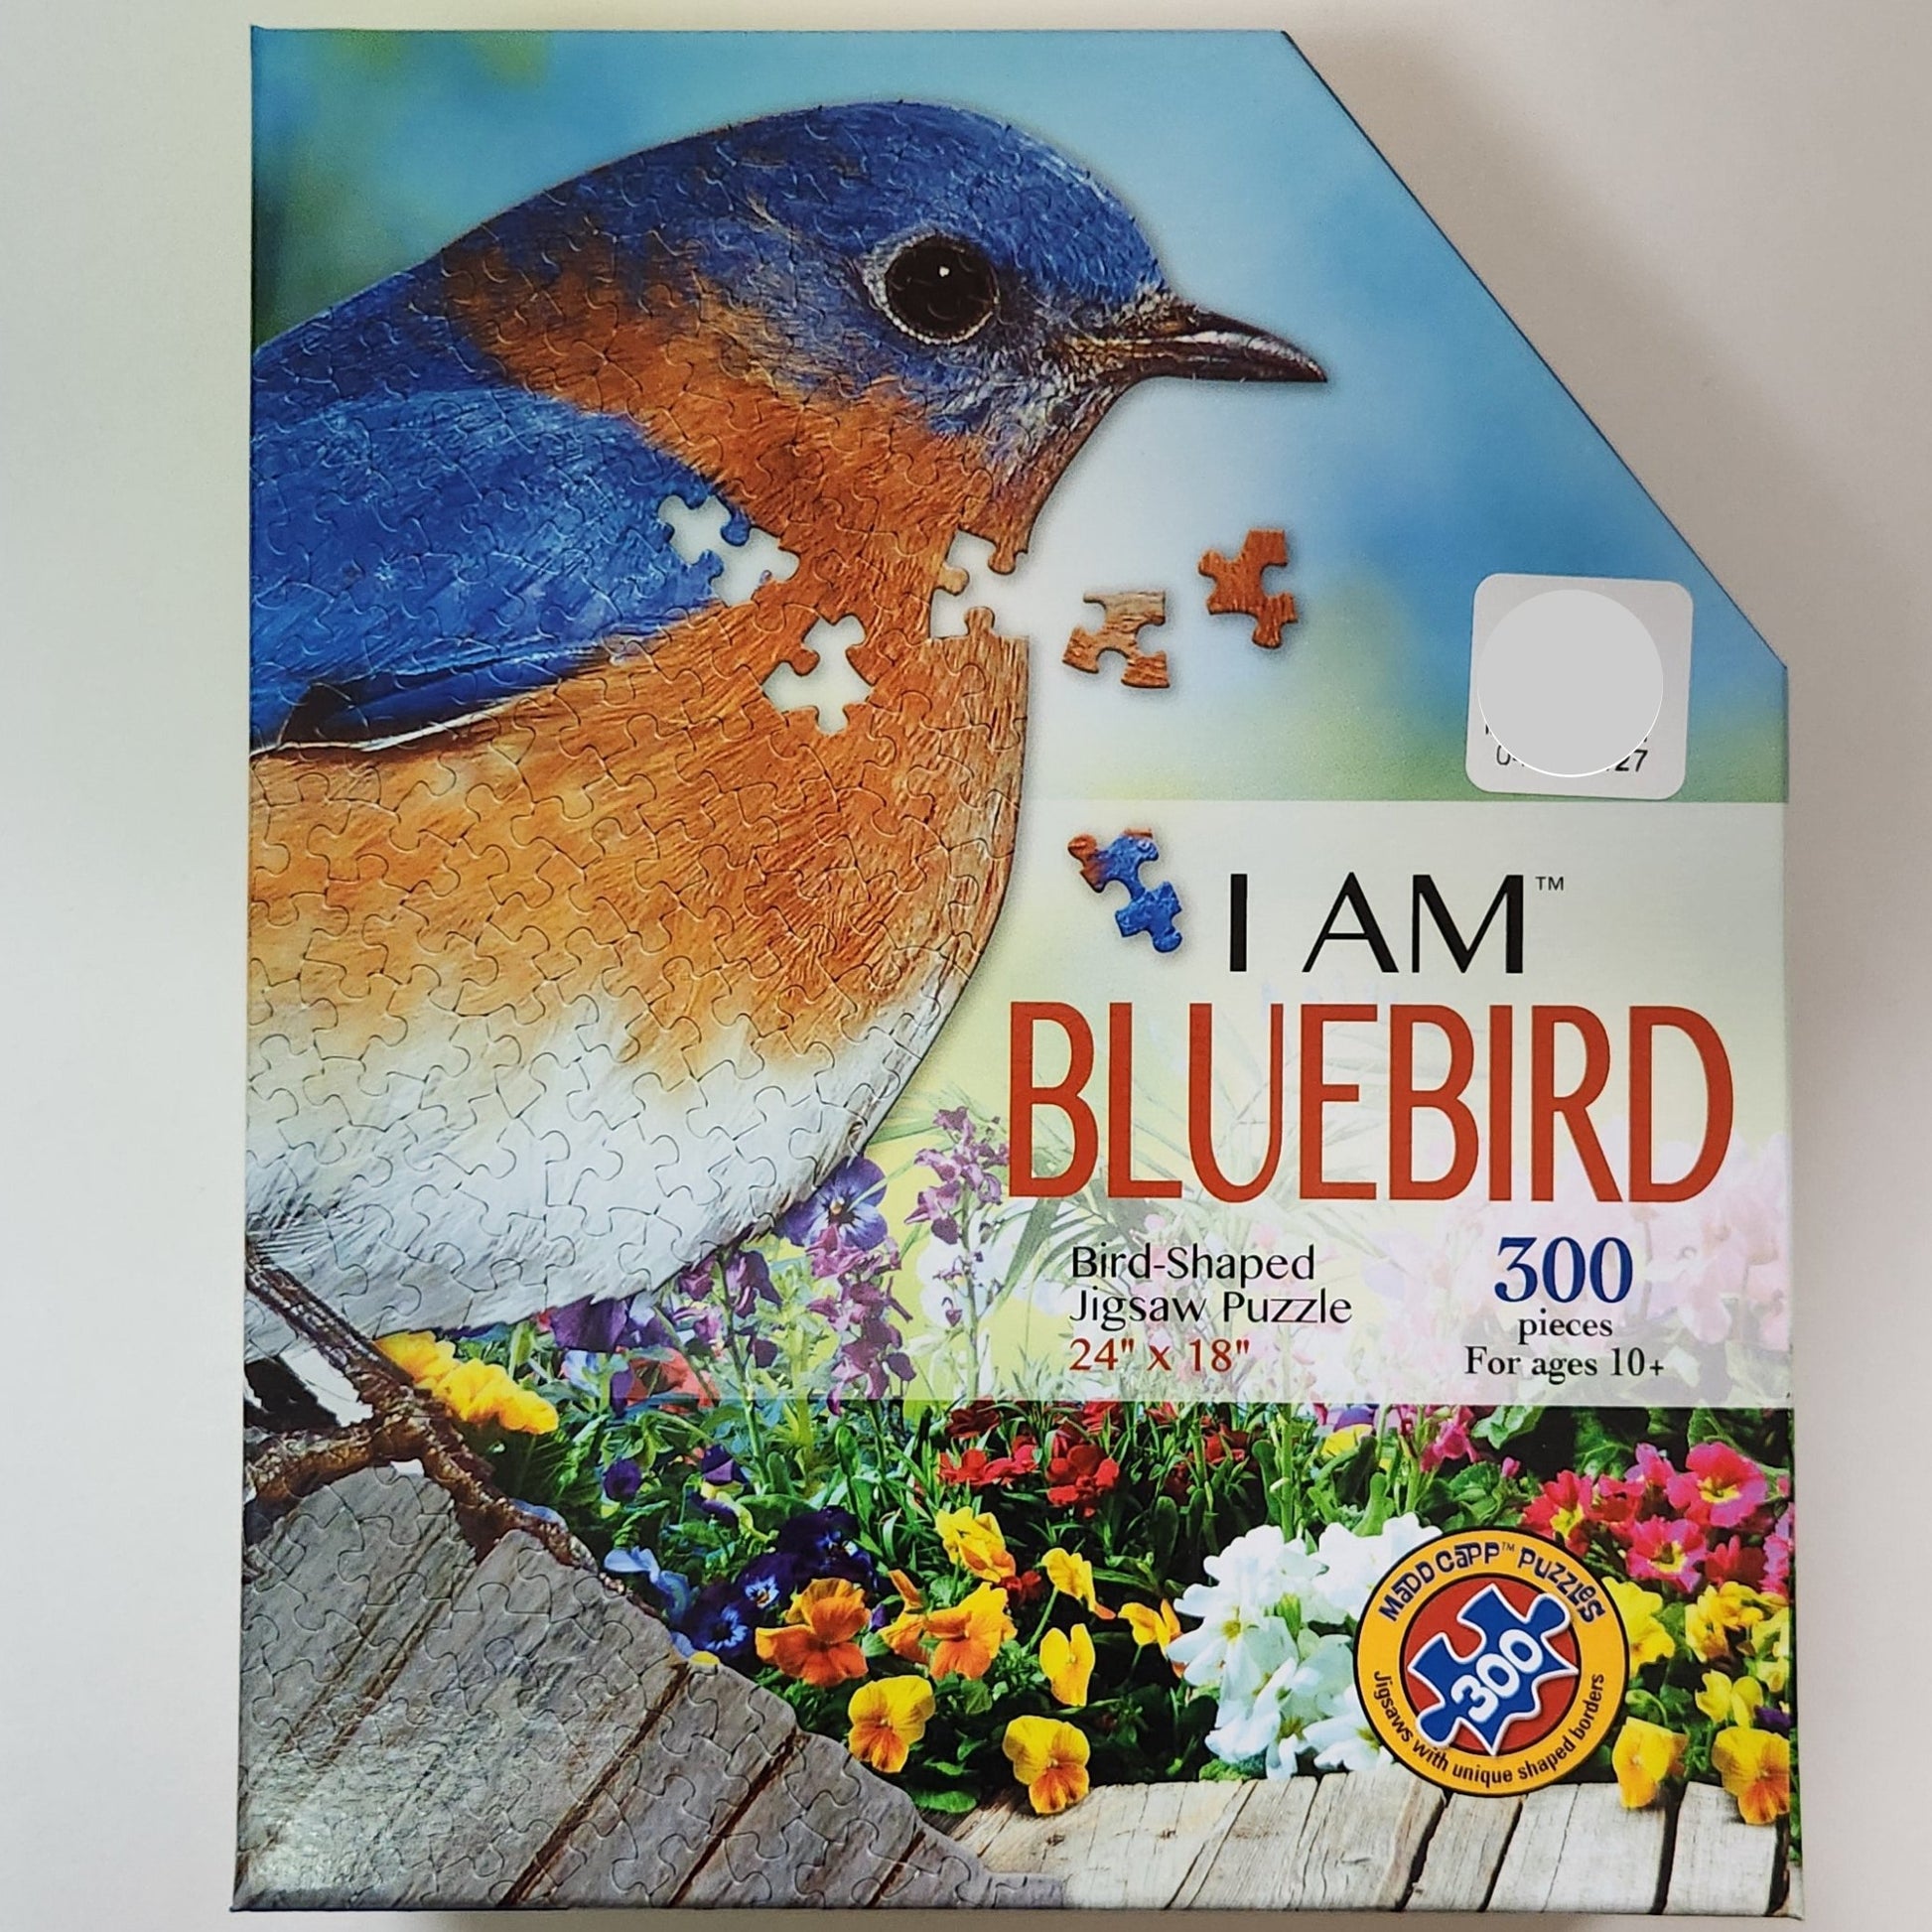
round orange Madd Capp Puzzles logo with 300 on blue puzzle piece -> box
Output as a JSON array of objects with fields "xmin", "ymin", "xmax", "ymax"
[{"xmin": 1354, "ymin": 1530, "xmax": 1628, "ymax": 1795}]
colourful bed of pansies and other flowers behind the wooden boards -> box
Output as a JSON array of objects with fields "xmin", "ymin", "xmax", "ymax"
[{"xmin": 364, "ymin": 1306, "xmax": 1795, "ymax": 1824}]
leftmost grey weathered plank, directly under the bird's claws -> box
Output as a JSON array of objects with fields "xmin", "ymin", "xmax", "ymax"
[{"xmin": 239, "ymin": 1468, "xmax": 476, "ymax": 1816}]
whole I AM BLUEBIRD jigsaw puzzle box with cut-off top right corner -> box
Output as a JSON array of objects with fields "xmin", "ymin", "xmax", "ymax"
[{"xmin": 235, "ymin": 22, "xmax": 1801, "ymax": 1914}]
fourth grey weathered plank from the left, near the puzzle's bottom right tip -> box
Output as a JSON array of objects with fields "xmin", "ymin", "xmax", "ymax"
[{"xmin": 678, "ymin": 1731, "xmax": 919, "ymax": 1905}]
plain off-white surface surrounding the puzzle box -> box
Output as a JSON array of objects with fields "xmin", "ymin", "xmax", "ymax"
[{"xmin": 0, "ymin": 0, "xmax": 1932, "ymax": 1932}]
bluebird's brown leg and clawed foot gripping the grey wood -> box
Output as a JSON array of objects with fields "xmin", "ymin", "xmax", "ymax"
[{"xmin": 247, "ymin": 1248, "xmax": 595, "ymax": 1573}]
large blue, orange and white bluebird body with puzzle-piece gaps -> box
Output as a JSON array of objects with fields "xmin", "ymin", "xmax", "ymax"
[{"xmin": 249, "ymin": 102, "xmax": 1321, "ymax": 1375}]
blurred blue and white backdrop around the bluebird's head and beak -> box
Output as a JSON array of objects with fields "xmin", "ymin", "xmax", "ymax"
[{"xmin": 255, "ymin": 33, "xmax": 1785, "ymax": 809}]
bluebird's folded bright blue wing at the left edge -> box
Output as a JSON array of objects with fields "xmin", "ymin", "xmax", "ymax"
[{"xmin": 249, "ymin": 386, "xmax": 726, "ymax": 748}]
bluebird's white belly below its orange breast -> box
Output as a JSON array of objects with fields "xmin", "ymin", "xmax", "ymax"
[{"xmin": 247, "ymin": 984, "xmax": 950, "ymax": 1352}]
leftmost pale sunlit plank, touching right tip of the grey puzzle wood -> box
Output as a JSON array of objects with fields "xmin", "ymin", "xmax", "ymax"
[{"xmin": 968, "ymin": 1783, "xmax": 1252, "ymax": 1909}]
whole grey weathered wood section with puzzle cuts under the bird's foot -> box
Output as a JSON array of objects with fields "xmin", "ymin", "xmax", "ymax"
[{"xmin": 235, "ymin": 1470, "xmax": 1058, "ymax": 1907}]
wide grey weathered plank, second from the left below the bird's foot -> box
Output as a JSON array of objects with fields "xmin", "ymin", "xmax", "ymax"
[{"xmin": 237, "ymin": 1536, "xmax": 686, "ymax": 1907}]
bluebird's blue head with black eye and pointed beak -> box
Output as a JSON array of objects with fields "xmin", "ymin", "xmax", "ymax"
[{"xmin": 460, "ymin": 102, "xmax": 1323, "ymax": 564}]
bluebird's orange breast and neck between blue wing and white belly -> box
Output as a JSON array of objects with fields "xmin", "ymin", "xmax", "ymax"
[{"xmin": 251, "ymin": 258, "xmax": 1026, "ymax": 1105}]
